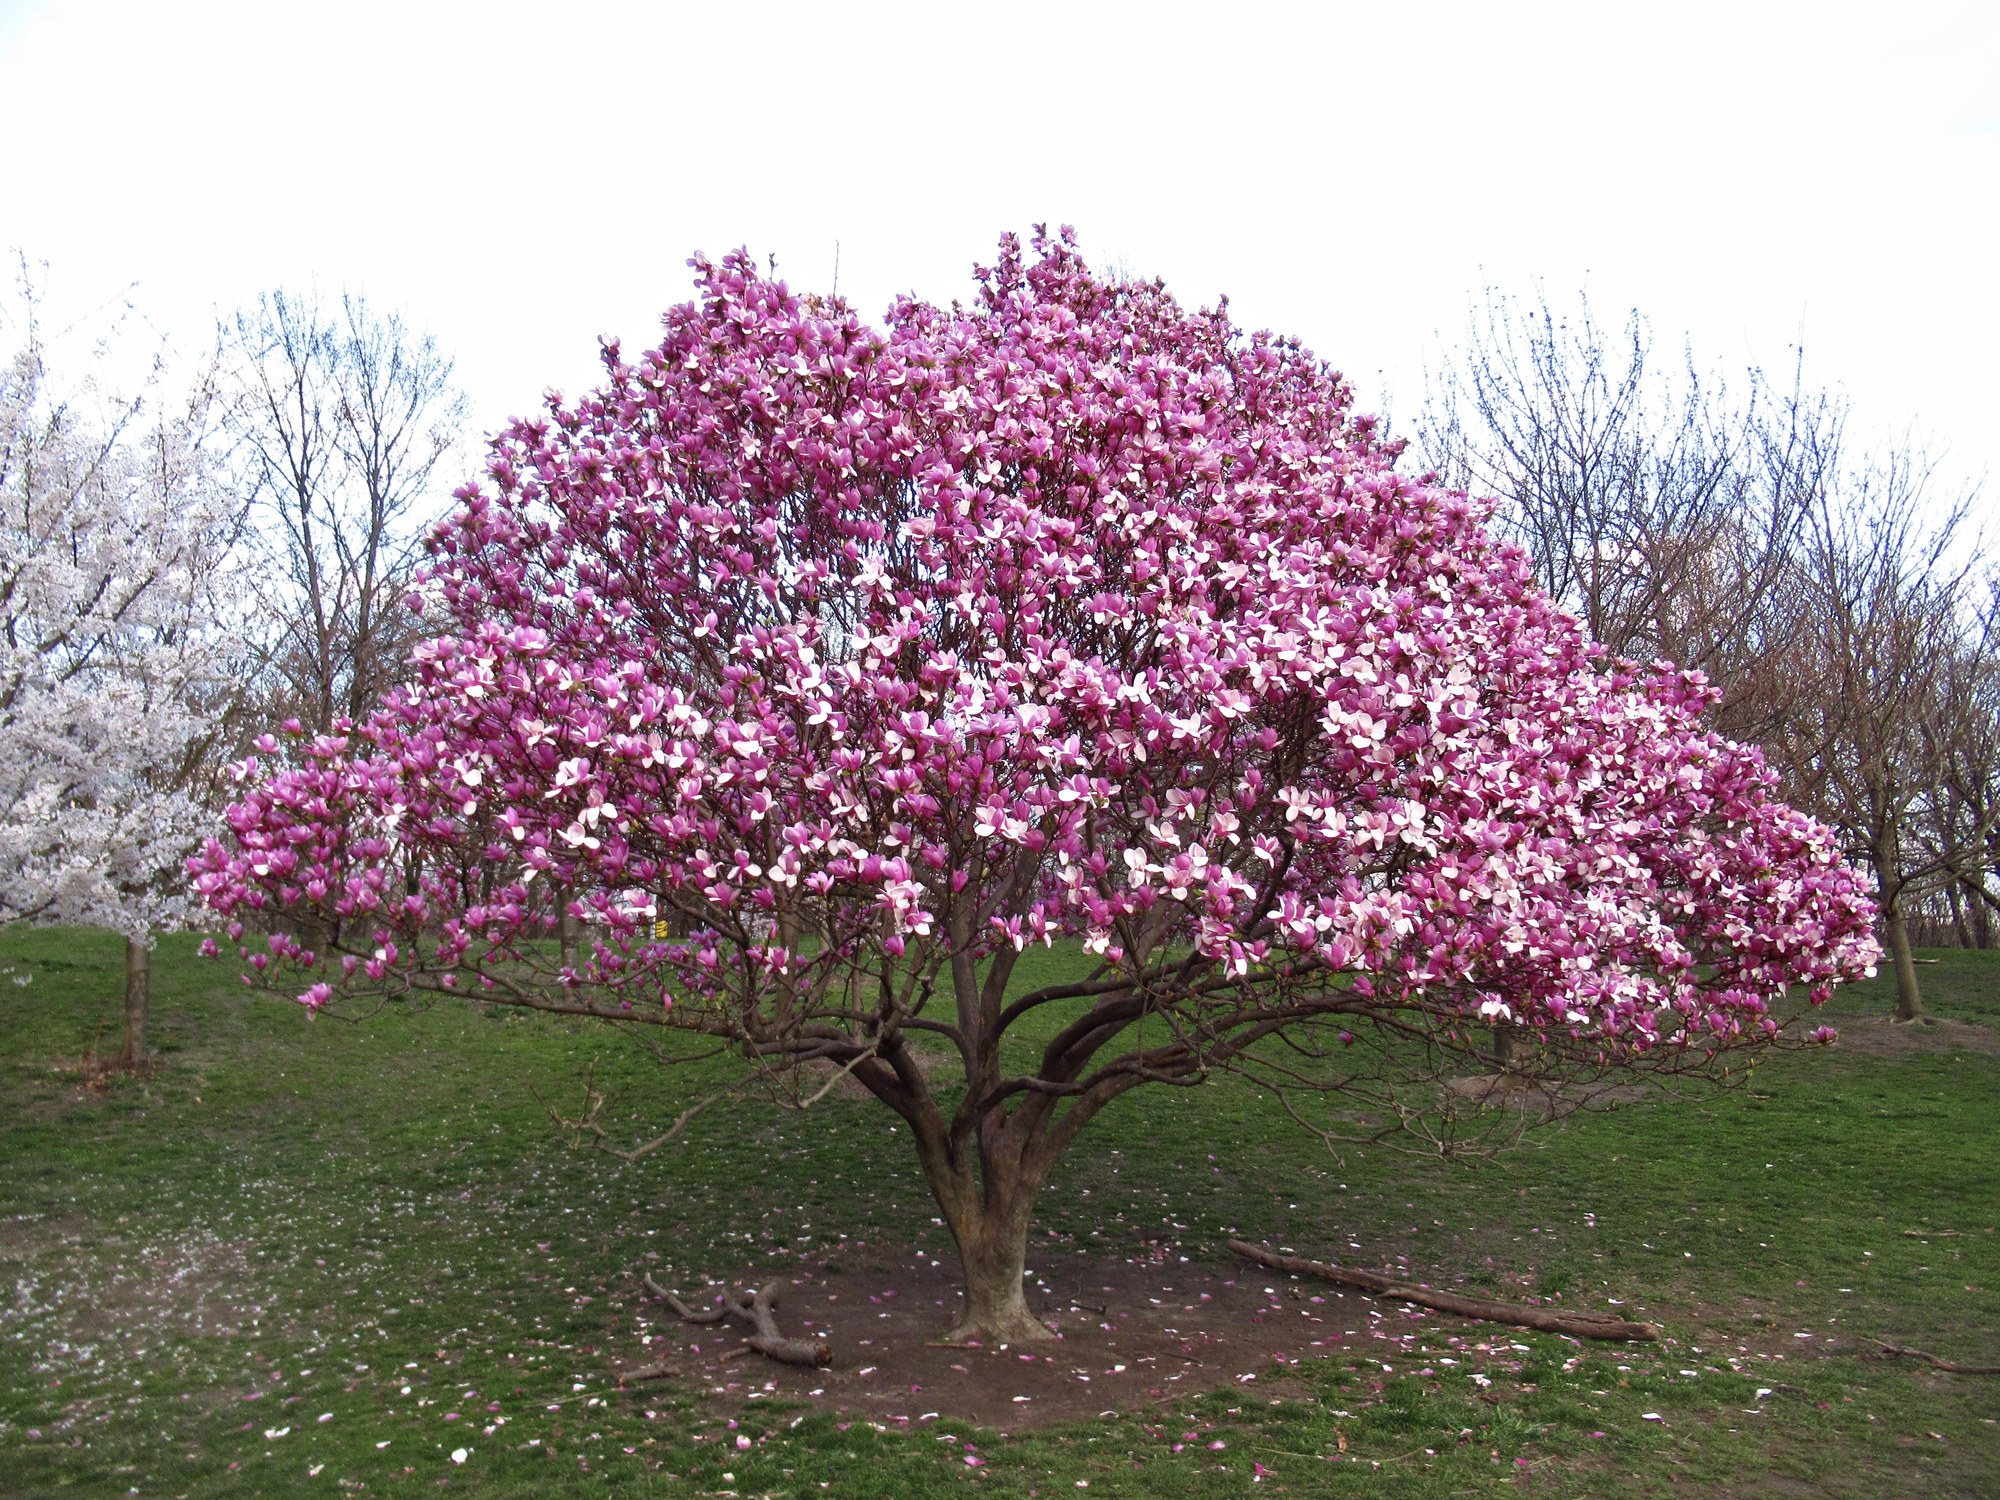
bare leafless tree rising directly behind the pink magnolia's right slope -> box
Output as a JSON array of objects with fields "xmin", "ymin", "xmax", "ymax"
[{"xmin": 1414, "ymin": 292, "xmax": 1844, "ymax": 738}]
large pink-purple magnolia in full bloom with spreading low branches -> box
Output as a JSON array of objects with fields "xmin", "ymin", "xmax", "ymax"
[{"xmin": 192, "ymin": 236, "xmax": 1876, "ymax": 1340}]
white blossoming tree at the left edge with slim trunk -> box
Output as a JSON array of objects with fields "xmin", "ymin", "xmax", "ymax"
[{"xmin": 0, "ymin": 278, "xmax": 240, "ymax": 1064}]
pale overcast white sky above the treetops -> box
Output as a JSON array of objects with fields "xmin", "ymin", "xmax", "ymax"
[{"xmin": 0, "ymin": 0, "xmax": 2000, "ymax": 494}]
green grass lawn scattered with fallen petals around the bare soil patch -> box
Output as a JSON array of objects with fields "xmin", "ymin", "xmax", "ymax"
[{"xmin": 0, "ymin": 928, "xmax": 2000, "ymax": 1500}]
